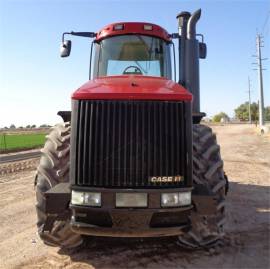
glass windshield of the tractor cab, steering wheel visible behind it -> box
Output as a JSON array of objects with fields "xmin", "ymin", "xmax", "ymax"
[{"xmin": 94, "ymin": 35, "xmax": 171, "ymax": 79}]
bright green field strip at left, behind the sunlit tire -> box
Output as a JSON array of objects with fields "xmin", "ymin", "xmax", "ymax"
[{"xmin": 0, "ymin": 133, "xmax": 46, "ymax": 153}]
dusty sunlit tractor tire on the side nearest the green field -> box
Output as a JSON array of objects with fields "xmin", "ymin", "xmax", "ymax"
[{"xmin": 35, "ymin": 123, "xmax": 82, "ymax": 248}]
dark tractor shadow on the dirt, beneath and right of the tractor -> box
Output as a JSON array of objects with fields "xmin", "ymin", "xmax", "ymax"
[{"xmin": 59, "ymin": 182, "xmax": 270, "ymax": 268}]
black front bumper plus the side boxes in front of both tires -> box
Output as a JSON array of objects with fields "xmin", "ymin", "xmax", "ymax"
[{"xmin": 43, "ymin": 183, "xmax": 218, "ymax": 237}]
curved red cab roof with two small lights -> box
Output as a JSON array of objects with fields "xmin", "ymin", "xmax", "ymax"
[{"xmin": 95, "ymin": 22, "xmax": 171, "ymax": 42}]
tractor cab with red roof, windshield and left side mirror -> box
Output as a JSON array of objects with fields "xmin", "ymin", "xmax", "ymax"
[{"xmin": 61, "ymin": 22, "xmax": 172, "ymax": 79}]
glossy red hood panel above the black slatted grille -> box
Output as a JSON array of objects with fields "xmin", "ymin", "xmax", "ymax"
[{"xmin": 72, "ymin": 75, "xmax": 192, "ymax": 101}]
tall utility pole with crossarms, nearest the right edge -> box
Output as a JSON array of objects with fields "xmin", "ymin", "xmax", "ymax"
[{"xmin": 256, "ymin": 34, "xmax": 264, "ymax": 127}]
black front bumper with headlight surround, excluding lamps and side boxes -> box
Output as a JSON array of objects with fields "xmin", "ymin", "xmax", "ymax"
[{"xmin": 70, "ymin": 188, "xmax": 192, "ymax": 237}]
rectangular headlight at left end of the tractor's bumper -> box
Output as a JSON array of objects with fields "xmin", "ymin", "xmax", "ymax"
[{"xmin": 71, "ymin": 191, "xmax": 101, "ymax": 206}]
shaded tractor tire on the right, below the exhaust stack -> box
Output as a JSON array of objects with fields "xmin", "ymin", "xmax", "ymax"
[{"xmin": 179, "ymin": 124, "xmax": 228, "ymax": 248}]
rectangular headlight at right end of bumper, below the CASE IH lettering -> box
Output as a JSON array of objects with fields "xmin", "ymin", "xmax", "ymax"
[{"xmin": 161, "ymin": 192, "xmax": 191, "ymax": 207}]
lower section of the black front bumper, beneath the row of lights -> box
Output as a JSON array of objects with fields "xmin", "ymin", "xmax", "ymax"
[{"xmin": 70, "ymin": 206, "xmax": 191, "ymax": 237}]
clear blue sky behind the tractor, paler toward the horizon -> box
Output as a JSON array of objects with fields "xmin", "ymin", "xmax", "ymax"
[{"xmin": 0, "ymin": 0, "xmax": 270, "ymax": 127}]
